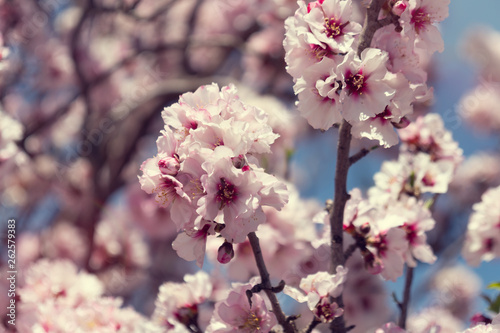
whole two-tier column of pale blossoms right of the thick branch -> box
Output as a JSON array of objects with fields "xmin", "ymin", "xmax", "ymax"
[{"xmin": 323, "ymin": 115, "xmax": 462, "ymax": 281}]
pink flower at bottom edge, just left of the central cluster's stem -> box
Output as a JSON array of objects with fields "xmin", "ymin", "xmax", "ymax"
[{"xmin": 206, "ymin": 278, "xmax": 278, "ymax": 333}]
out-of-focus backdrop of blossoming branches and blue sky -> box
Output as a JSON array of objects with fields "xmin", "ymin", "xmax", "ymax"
[{"xmin": 0, "ymin": 0, "xmax": 500, "ymax": 330}]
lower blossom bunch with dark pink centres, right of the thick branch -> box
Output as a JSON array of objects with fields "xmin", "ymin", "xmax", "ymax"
[{"xmin": 344, "ymin": 189, "xmax": 436, "ymax": 281}]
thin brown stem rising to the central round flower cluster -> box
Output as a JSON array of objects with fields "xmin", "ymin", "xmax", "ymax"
[{"xmin": 248, "ymin": 232, "xmax": 297, "ymax": 333}]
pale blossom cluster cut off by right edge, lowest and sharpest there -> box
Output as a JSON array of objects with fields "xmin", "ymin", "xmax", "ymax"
[{"xmin": 462, "ymin": 187, "xmax": 500, "ymax": 266}]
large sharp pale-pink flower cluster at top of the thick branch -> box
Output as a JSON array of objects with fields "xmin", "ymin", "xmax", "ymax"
[{"xmin": 284, "ymin": 0, "xmax": 449, "ymax": 147}]
